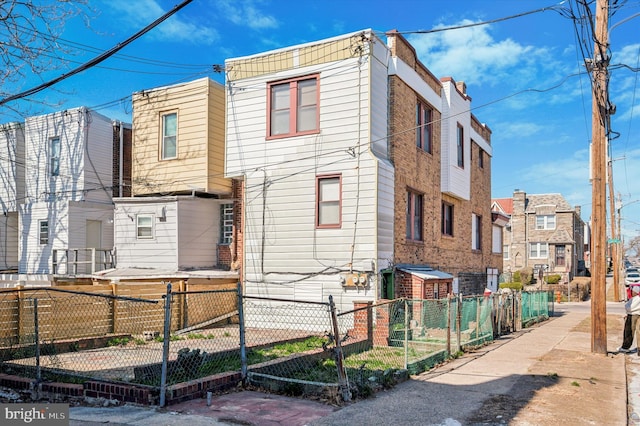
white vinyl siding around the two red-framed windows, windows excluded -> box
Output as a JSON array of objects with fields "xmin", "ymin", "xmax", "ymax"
[{"xmin": 225, "ymin": 30, "xmax": 380, "ymax": 309}]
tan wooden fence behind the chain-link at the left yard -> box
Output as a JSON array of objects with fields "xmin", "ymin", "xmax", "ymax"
[{"xmin": 0, "ymin": 281, "xmax": 237, "ymax": 347}]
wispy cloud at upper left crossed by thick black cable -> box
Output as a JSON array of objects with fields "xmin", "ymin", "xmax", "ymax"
[{"xmin": 109, "ymin": 0, "xmax": 219, "ymax": 44}]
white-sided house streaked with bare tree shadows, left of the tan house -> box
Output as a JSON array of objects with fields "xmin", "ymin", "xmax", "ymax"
[{"xmin": 18, "ymin": 107, "xmax": 113, "ymax": 274}]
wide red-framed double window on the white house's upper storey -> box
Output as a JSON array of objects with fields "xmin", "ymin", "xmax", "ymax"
[{"xmin": 267, "ymin": 76, "xmax": 320, "ymax": 137}]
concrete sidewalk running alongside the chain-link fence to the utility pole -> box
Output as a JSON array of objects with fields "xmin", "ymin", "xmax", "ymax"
[{"xmin": 70, "ymin": 302, "xmax": 640, "ymax": 426}]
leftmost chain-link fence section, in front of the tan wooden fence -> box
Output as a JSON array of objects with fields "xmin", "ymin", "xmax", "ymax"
[{"xmin": 0, "ymin": 288, "xmax": 163, "ymax": 382}]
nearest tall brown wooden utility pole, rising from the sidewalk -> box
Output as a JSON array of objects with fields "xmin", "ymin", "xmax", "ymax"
[{"xmin": 591, "ymin": 0, "xmax": 609, "ymax": 354}]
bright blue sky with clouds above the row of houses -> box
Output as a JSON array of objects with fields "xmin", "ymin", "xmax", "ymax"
[{"xmin": 0, "ymin": 0, "xmax": 640, "ymax": 240}]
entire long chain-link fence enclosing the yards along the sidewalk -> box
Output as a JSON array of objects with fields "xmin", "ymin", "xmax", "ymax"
[{"xmin": 0, "ymin": 284, "xmax": 553, "ymax": 406}]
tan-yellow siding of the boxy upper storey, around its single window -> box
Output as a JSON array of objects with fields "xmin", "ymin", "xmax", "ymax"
[{"xmin": 132, "ymin": 78, "xmax": 231, "ymax": 195}]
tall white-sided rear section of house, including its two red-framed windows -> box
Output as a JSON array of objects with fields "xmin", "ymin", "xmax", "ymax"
[{"xmin": 225, "ymin": 31, "xmax": 394, "ymax": 310}]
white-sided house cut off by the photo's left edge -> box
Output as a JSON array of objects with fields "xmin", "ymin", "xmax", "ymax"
[{"xmin": 0, "ymin": 123, "xmax": 24, "ymax": 271}]
